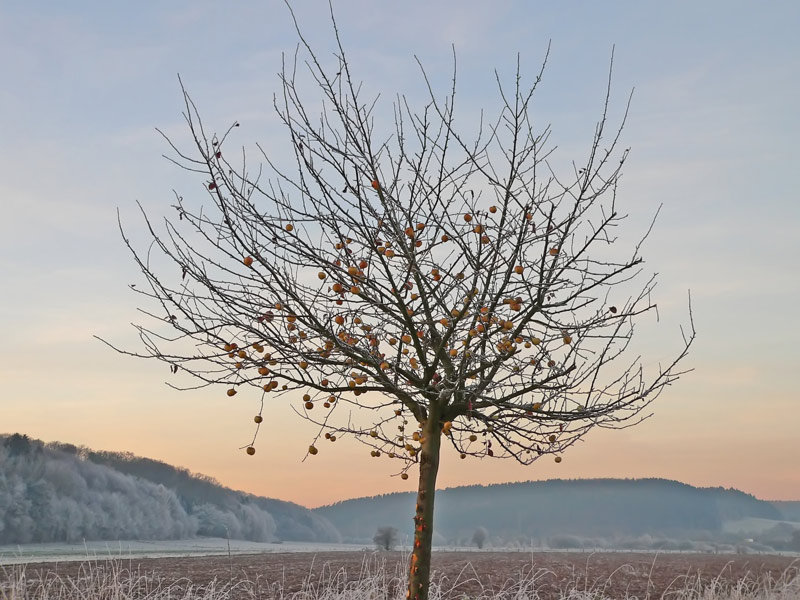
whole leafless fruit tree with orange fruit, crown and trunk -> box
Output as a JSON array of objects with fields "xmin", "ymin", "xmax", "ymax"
[{"xmin": 104, "ymin": 5, "xmax": 694, "ymax": 600}]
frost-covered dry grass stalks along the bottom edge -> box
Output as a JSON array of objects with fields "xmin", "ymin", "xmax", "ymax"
[{"xmin": 0, "ymin": 555, "xmax": 800, "ymax": 600}]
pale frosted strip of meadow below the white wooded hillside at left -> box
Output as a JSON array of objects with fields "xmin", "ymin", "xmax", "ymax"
[{"xmin": 0, "ymin": 538, "xmax": 372, "ymax": 565}]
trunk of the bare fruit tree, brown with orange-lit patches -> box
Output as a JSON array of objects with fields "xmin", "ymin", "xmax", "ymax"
[{"xmin": 406, "ymin": 403, "xmax": 442, "ymax": 600}]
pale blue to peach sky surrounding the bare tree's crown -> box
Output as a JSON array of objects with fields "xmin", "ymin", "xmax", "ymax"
[{"xmin": 0, "ymin": 0, "xmax": 800, "ymax": 507}]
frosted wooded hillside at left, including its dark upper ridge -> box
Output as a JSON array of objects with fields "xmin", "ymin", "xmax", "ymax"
[{"xmin": 0, "ymin": 434, "xmax": 340, "ymax": 544}]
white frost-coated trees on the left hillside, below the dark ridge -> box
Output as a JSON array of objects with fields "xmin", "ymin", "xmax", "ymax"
[{"xmin": 0, "ymin": 435, "xmax": 290, "ymax": 544}]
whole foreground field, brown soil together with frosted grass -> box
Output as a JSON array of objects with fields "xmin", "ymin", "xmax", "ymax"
[{"xmin": 0, "ymin": 551, "xmax": 800, "ymax": 600}]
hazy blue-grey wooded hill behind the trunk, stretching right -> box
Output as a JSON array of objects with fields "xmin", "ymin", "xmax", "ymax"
[{"xmin": 315, "ymin": 479, "xmax": 781, "ymax": 543}]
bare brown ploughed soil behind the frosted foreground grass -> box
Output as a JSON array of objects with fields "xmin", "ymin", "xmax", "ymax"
[{"xmin": 7, "ymin": 552, "xmax": 800, "ymax": 599}]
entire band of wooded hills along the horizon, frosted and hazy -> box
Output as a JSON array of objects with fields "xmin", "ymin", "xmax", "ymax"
[{"xmin": 0, "ymin": 434, "xmax": 800, "ymax": 551}]
